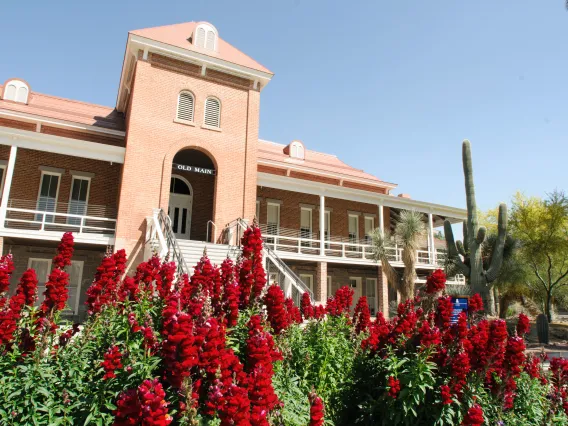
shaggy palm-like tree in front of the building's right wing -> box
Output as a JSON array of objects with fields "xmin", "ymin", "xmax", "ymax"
[{"xmin": 372, "ymin": 210, "xmax": 426, "ymax": 302}]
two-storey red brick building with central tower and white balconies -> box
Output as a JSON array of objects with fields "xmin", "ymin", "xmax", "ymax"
[{"xmin": 0, "ymin": 22, "xmax": 465, "ymax": 316}]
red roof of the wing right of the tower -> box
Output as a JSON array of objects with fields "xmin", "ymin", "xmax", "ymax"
[{"xmin": 258, "ymin": 140, "xmax": 396, "ymax": 187}]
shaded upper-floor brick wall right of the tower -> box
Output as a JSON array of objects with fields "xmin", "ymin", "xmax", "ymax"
[{"xmin": 257, "ymin": 186, "xmax": 390, "ymax": 238}]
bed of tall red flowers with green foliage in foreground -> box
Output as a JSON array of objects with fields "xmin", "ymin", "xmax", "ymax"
[{"xmin": 0, "ymin": 227, "xmax": 568, "ymax": 426}]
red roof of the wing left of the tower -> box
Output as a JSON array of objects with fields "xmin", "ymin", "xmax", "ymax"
[{"xmin": 0, "ymin": 86, "xmax": 125, "ymax": 131}]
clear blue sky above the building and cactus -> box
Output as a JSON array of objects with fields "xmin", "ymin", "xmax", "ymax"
[{"xmin": 0, "ymin": 0, "xmax": 568, "ymax": 213}]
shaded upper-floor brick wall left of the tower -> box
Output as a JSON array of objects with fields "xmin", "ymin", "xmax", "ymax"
[{"xmin": 0, "ymin": 145, "xmax": 122, "ymax": 214}]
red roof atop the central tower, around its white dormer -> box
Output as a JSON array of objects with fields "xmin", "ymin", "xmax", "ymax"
[{"xmin": 130, "ymin": 22, "xmax": 273, "ymax": 74}]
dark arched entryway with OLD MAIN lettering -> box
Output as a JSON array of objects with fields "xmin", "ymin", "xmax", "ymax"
[{"xmin": 168, "ymin": 149, "xmax": 217, "ymax": 241}]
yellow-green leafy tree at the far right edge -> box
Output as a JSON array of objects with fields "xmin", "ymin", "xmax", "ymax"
[{"xmin": 511, "ymin": 191, "xmax": 568, "ymax": 322}]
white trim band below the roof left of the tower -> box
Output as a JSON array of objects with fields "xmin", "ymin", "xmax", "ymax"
[{"xmin": 0, "ymin": 128, "xmax": 126, "ymax": 164}]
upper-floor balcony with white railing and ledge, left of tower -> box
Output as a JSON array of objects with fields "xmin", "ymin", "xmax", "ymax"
[{"xmin": 0, "ymin": 198, "xmax": 117, "ymax": 245}]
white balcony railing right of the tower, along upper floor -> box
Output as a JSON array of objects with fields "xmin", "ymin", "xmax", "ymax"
[{"xmin": 260, "ymin": 224, "xmax": 446, "ymax": 266}]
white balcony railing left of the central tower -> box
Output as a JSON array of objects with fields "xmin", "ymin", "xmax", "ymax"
[{"xmin": 4, "ymin": 199, "xmax": 116, "ymax": 237}]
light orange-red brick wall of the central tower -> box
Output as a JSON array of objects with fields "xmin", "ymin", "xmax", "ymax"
[{"xmin": 117, "ymin": 53, "xmax": 260, "ymax": 255}]
